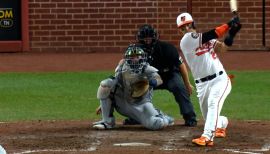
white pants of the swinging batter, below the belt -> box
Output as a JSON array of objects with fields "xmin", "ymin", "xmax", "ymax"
[{"xmin": 196, "ymin": 73, "xmax": 232, "ymax": 140}]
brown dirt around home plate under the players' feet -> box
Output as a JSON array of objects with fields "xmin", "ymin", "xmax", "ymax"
[{"xmin": 0, "ymin": 121, "xmax": 270, "ymax": 154}]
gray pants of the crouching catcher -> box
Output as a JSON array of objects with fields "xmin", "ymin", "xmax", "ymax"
[{"xmin": 101, "ymin": 91, "xmax": 169, "ymax": 130}]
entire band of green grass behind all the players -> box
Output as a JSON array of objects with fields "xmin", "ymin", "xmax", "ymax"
[{"xmin": 0, "ymin": 71, "xmax": 270, "ymax": 121}]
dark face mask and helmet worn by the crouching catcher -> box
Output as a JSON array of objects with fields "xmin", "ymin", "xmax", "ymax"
[{"xmin": 125, "ymin": 44, "xmax": 146, "ymax": 74}]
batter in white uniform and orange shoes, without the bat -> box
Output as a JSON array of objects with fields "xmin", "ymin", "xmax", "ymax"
[{"xmin": 176, "ymin": 13, "xmax": 241, "ymax": 146}]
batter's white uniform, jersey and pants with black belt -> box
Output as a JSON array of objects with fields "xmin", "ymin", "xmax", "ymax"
[{"xmin": 180, "ymin": 32, "xmax": 231, "ymax": 140}]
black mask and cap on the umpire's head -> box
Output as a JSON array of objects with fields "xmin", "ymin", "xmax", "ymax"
[{"xmin": 137, "ymin": 24, "xmax": 158, "ymax": 45}]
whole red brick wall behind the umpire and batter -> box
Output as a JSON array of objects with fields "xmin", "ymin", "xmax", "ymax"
[{"xmin": 29, "ymin": 0, "xmax": 270, "ymax": 52}]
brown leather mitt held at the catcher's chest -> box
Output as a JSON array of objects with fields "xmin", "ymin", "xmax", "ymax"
[{"xmin": 131, "ymin": 80, "xmax": 149, "ymax": 98}]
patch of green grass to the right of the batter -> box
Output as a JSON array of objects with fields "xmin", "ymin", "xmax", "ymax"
[{"xmin": 223, "ymin": 71, "xmax": 270, "ymax": 120}]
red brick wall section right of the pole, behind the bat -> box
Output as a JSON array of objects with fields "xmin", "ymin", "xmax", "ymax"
[{"xmin": 192, "ymin": 0, "xmax": 270, "ymax": 50}]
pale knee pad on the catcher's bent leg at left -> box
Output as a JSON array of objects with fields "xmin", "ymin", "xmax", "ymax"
[{"xmin": 97, "ymin": 78, "xmax": 114, "ymax": 99}]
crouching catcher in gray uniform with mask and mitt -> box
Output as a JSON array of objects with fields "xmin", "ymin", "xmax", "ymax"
[{"xmin": 93, "ymin": 45, "xmax": 174, "ymax": 130}]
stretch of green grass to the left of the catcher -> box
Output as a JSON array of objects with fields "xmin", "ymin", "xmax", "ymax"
[{"xmin": 0, "ymin": 72, "xmax": 108, "ymax": 121}]
